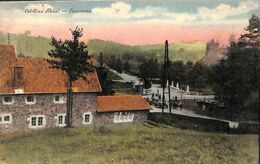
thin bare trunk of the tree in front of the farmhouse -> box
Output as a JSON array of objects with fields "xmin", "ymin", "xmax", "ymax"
[{"xmin": 66, "ymin": 79, "xmax": 73, "ymax": 128}]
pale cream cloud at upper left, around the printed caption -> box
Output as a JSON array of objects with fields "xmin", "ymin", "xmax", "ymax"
[{"xmin": 0, "ymin": 3, "xmax": 68, "ymax": 36}]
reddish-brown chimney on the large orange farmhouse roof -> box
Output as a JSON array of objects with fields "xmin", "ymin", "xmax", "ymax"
[{"xmin": 13, "ymin": 66, "xmax": 24, "ymax": 89}]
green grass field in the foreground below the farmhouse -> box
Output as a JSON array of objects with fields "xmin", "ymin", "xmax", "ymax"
[{"xmin": 0, "ymin": 124, "xmax": 258, "ymax": 164}]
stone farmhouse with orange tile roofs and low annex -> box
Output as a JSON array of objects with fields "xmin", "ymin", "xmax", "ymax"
[{"xmin": 0, "ymin": 45, "xmax": 150, "ymax": 133}]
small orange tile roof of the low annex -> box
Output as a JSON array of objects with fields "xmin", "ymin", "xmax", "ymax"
[{"xmin": 97, "ymin": 95, "xmax": 151, "ymax": 112}]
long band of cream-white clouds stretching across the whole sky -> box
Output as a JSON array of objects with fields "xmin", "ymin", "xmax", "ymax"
[{"xmin": 0, "ymin": 1, "xmax": 259, "ymax": 34}]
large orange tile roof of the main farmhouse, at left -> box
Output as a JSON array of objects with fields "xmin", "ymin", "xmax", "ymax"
[{"xmin": 0, "ymin": 45, "xmax": 101, "ymax": 94}]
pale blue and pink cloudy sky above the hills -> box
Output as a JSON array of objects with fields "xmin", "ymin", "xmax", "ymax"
[{"xmin": 0, "ymin": 0, "xmax": 260, "ymax": 45}]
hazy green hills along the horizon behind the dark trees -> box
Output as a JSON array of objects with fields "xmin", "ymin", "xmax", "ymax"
[{"xmin": 0, "ymin": 31, "xmax": 206, "ymax": 62}]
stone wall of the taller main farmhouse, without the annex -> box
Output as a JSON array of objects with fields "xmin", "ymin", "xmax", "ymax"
[{"xmin": 0, "ymin": 93, "xmax": 97, "ymax": 133}]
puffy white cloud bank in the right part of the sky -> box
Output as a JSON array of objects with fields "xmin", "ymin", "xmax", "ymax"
[{"xmin": 92, "ymin": 1, "xmax": 259, "ymax": 24}]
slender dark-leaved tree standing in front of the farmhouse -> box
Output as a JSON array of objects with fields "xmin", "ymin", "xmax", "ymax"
[{"xmin": 46, "ymin": 27, "xmax": 94, "ymax": 127}]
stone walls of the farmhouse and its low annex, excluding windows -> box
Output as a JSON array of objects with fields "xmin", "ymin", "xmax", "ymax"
[{"xmin": 0, "ymin": 93, "xmax": 149, "ymax": 133}]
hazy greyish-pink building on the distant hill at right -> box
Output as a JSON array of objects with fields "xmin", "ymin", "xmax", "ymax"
[{"xmin": 200, "ymin": 39, "xmax": 227, "ymax": 66}]
